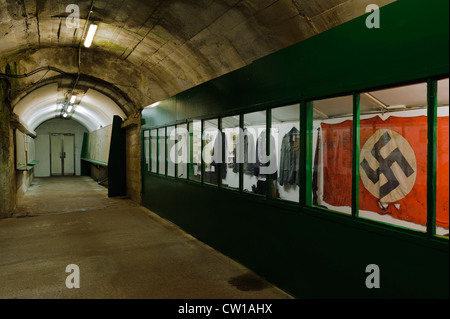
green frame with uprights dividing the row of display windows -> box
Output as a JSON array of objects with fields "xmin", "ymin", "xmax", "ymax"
[{"xmin": 142, "ymin": 74, "xmax": 448, "ymax": 242}]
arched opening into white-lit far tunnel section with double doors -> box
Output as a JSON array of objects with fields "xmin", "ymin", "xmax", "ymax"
[{"xmin": 4, "ymin": 73, "xmax": 134, "ymax": 206}]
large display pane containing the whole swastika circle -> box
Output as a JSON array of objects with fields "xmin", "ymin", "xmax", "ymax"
[{"xmin": 359, "ymin": 83, "xmax": 428, "ymax": 232}]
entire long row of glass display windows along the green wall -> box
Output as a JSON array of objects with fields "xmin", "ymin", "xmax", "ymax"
[{"xmin": 143, "ymin": 78, "xmax": 449, "ymax": 244}]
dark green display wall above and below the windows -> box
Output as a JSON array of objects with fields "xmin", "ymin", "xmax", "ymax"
[{"xmin": 142, "ymin": 0, "xmax": 449, "ymax": 298}]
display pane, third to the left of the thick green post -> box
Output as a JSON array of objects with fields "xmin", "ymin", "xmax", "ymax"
[{"xmin": 222, "ymin": 116, "xmax": 241, "ymax": 190}]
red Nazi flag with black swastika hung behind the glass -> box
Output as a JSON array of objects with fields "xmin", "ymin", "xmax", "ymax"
[{"xmin": 322, "ymin": 116, "xmax": 449, "ymax": 228}]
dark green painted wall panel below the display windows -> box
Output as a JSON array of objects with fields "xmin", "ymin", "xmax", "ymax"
[{"xmin": 144, "ymin": 175, "xmax": 449, "ymax": 298}]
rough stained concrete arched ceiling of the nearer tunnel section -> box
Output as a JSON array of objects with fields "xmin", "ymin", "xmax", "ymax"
[{"xmin": 0, "ymin": 0, "xmax": 394, "ymax": 116}]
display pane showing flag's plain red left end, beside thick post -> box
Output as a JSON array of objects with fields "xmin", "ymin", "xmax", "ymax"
[{"xmin": 311, "ymin": 96, "xmax": 353, "ymax": 215}]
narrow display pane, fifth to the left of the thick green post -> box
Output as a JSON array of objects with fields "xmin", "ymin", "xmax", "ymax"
[{"xmin": 189, "ymin": 121, "xmax": 202, "ymax": 182}]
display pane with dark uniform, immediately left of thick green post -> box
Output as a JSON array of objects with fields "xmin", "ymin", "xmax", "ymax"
[{"xmin": 271, "ymin": 104, "xmax": 300, "ymax": 202}]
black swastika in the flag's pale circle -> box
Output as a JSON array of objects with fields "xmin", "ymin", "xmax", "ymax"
[{"xmin": 361, "ymin": 132, "xmax": 415, "ymax": 199}]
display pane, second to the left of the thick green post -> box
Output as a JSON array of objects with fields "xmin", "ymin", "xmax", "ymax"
[{"xmin": 243, "ymin": 111, "xmax": 269, "ymax": 196}]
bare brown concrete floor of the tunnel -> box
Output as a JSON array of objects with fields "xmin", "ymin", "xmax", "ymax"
[{"xmin": 0, "ymin": 177, "xmax": 291, "ymax": 299}]
